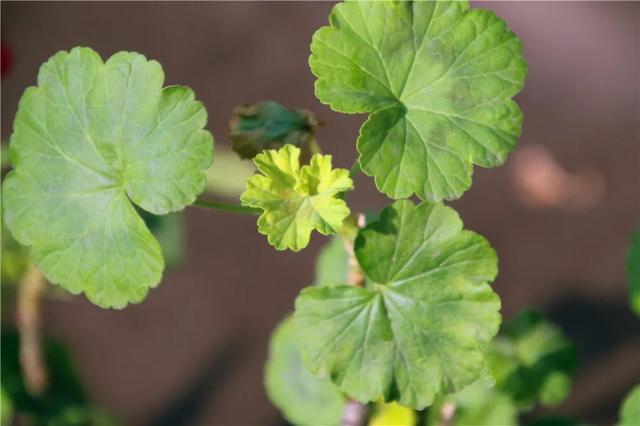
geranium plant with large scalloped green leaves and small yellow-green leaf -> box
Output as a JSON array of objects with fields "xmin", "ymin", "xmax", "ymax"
[{"xmin": 2, "ymin": 1, "xmax": 636, "ymax": 424}]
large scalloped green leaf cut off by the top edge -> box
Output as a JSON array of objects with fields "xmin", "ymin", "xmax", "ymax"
[{"xmin": 309, "ymin": 1, "xmax": 527, "ymax": 201}]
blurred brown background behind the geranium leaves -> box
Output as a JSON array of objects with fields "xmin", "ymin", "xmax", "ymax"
[{"xmin": 1, "ymin": 2, "xmax": 640, "ymax": 425}]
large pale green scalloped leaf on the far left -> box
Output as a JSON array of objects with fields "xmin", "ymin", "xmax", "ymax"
[{"xmin": 3, "ymin": 48, "xmax": 213, "ymax": 308}]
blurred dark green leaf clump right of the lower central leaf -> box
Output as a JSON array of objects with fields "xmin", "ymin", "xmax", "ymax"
[{"xmin": 490, "ymin": 310, "xmax": 576, "ymax": 410}]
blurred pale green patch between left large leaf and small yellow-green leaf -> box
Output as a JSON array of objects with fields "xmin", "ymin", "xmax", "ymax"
[{"xmin": 206, "ymin": 146, "xmax": 256, "ymax": 199}]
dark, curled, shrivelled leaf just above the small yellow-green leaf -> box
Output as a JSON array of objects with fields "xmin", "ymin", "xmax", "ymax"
[{"xmin": 229, "ymin": 101, "xmax": 319, "ymax": 163}]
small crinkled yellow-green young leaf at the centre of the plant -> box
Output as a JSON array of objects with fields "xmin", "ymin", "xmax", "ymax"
[{"xmin": 240, "ymin": 145, "xmax": 353, "ymax": 251}]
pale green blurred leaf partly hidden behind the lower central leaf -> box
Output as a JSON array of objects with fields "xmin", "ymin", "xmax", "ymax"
[{"xmin": 265, "ymin": 317, "xmax": 345, "ymax": 426}]
